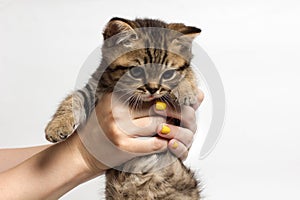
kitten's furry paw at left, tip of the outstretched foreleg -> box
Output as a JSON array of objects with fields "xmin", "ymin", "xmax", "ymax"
[{"xmin": 45, "ymin": 114, "xmax": 75, "ymax": 142}]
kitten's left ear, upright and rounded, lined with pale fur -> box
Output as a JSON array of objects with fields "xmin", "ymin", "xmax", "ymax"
[{"xmin": 103, "ymin": 17, "xmax": 138, "ymax": 47}]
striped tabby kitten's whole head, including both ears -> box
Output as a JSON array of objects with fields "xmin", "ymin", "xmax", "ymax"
[{"xmin": 100, "ymin": 18, "xmax": 200, "ymax": 104}]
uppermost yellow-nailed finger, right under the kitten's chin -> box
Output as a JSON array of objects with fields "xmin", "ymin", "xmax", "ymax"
[{"xmin": 154, "ymin": 105, "xmax": 197, "ymax": 132}]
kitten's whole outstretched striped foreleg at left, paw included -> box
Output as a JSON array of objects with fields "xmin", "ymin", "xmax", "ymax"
[{"xmin": 45, "ymin": 81, "xmax": 95, "ymax": 142}]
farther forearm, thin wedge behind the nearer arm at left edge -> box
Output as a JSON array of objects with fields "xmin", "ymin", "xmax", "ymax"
[{"xmin": 0, "ymin": 145, "xmax": 50, "ymax": 173}]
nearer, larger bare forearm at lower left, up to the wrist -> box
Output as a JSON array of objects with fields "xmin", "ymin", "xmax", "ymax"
[{"xmin": 0, "ymin": 133, "xmax": 104, "ymax": 200}]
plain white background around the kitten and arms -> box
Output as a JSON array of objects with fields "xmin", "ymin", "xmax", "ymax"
[{"xmin": 0, "ymin": 0, "xmax": 300, "ymax": 200}]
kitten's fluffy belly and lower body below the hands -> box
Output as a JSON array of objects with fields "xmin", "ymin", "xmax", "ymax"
[{"xmin": 106, "ymin": 152, "xmax": 200, "ymax": 200}]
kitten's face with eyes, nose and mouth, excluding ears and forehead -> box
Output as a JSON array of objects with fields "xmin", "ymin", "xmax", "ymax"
[{"xmin": 110, "ymin": 49, "xmax": 188, "ymax": 101}]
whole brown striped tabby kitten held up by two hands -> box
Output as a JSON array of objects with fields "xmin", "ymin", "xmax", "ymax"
[{"xmin": 45, "ymin": 18, "xmax": 200, "ymax": 200}]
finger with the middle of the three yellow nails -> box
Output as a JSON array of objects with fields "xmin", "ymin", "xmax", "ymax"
[{"xmin": 157, "ymin": 124, "xmax": 194, "ymax": 148}]
